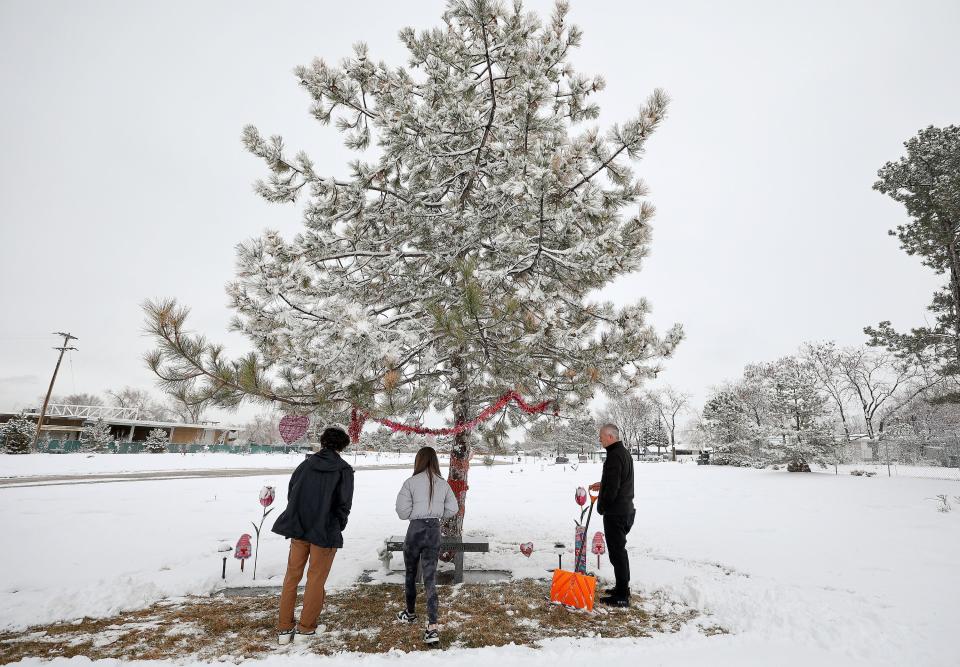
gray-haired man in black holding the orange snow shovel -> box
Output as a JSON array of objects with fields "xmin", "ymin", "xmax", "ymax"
[{"xmin": 590, "ymin": 424, "xmax": 637, "ymax": 607}]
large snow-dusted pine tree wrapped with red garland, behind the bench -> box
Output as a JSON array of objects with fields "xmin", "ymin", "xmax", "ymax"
[{"xmin": 145, "ymin": 0, "xmax": 682, "ymax": 534}]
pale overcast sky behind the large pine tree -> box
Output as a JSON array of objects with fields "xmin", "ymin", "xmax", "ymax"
[{"xmin": 0, "ymin": 0, "xmax": 960, "ymax": 426}]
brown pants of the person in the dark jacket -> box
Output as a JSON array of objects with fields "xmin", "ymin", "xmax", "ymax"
[{"xmin": 278, "ymin": 540, "xmax": 337, "ymax": 632}]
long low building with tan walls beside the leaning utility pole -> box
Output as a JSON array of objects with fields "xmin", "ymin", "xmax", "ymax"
[{"xmin": 0, "ymin": 405, "xmax": 240, "ymax": 445}]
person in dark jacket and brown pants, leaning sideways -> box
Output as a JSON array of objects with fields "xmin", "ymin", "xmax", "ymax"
[{"xmin": 273, "ymin": 427, "xmax": 353, "ymax": 644}]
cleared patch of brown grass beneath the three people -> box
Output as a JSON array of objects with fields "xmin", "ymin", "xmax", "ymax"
[{"xmin": 0, "ymin": 580, "xmax": 727, "ymax": 663}]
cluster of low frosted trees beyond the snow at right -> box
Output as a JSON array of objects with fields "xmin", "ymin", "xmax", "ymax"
[{"xmin": 698, "ymin": 341, "xmax": 944, "ymax": 469}]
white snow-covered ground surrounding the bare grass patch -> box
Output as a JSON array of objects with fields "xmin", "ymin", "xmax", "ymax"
[{"xmin": 0, "ymin": 455, "xmax": 960, "ymax": 667}]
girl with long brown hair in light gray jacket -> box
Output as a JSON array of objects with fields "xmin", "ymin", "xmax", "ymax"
[{"xmin": 397, "ymin": 447, "xmax": 460, "ymax": 644}]
